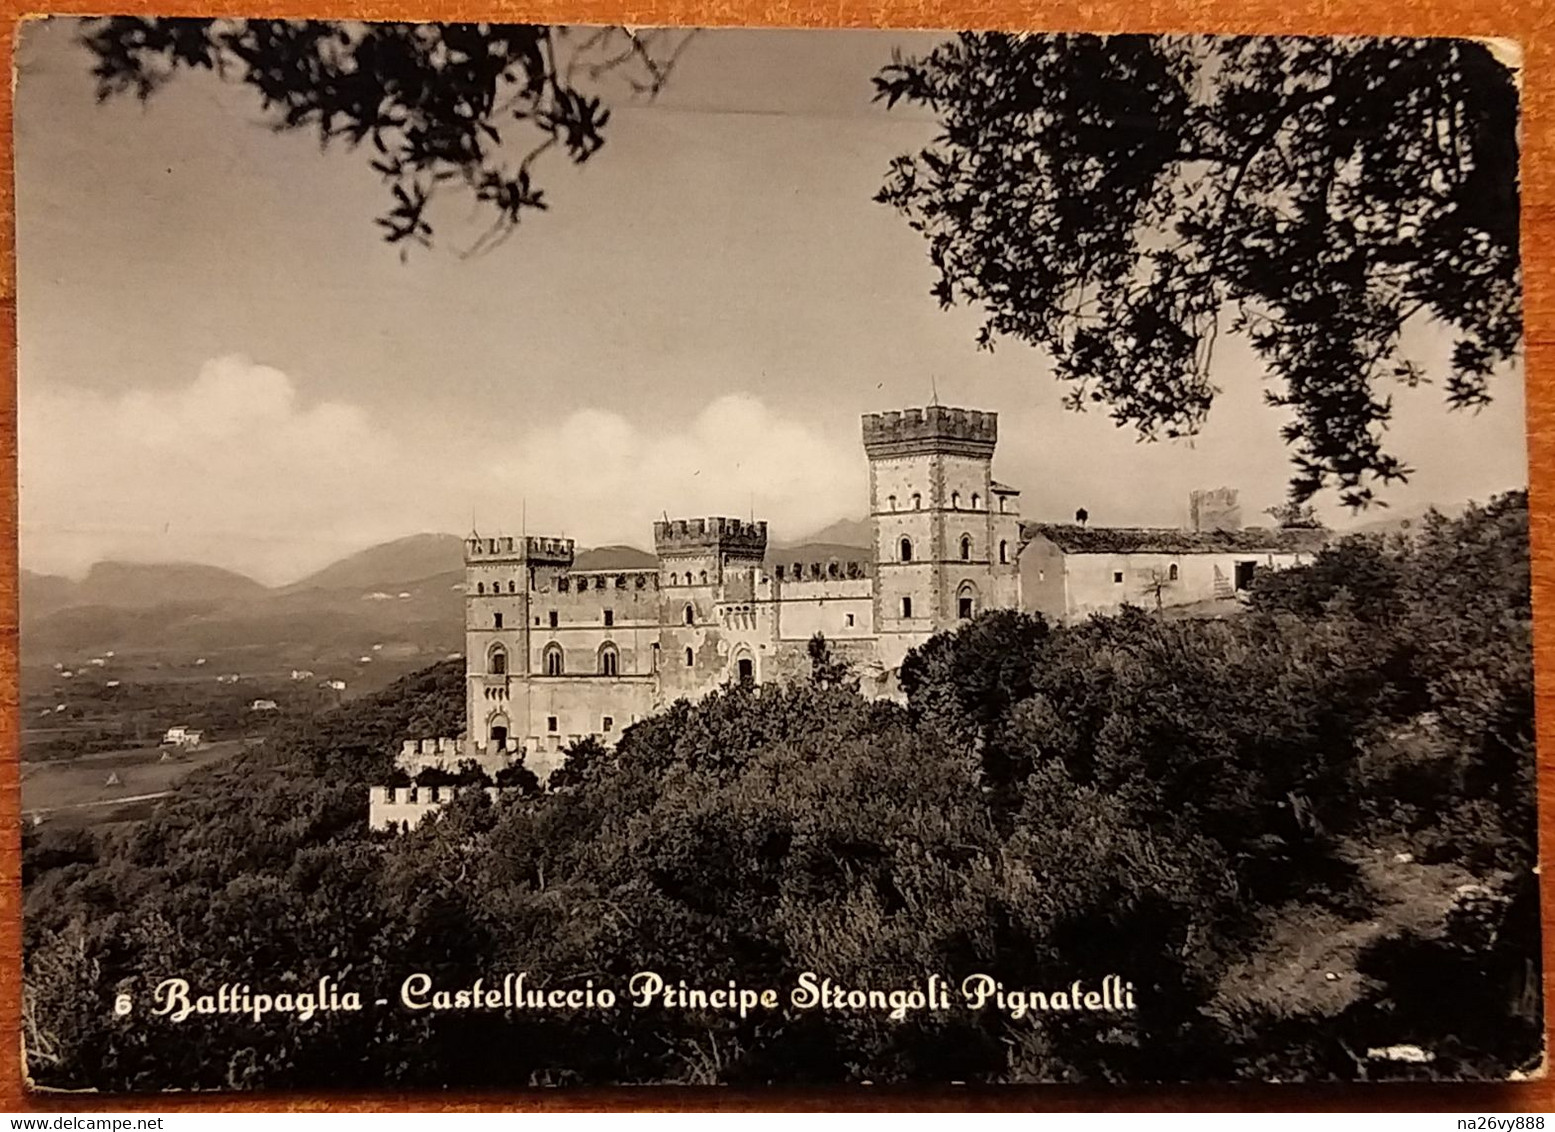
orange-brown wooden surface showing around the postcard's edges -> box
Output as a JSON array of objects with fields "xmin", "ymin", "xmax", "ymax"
[{"xmin": 0, "ymin": 0, "xmax": 1555, "ymax": 1115}]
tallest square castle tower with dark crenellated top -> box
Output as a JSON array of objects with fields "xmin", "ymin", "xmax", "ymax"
[{"xmin": 863, "ymin": 404, "xmax": 1020, "ymax": 667}]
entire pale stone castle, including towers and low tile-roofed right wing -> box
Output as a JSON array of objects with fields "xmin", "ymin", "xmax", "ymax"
[{"xmin": 372, "ymin": 406, "xmax": 1322, "ymax": 827}]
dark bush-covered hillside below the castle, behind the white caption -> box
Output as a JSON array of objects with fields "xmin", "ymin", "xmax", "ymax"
[{"xmin": 26, "ymin": 496, "xmax": 1541, "ymax": 1088}]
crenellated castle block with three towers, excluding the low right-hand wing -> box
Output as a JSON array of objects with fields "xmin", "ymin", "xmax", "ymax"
[{"xmin": 370, "ymin": 404, "xmax": 1038, "ymax": 830}]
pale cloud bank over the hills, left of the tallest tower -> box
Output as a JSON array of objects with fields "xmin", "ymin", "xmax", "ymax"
[{"xmin": 19, "ymin": 356, "xmax": 866, "ymax": 583}]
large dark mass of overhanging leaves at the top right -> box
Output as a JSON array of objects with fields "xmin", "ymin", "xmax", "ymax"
[{"xmin": 875, "ymin": 33, "xmax": 1522, "ymax": 507}]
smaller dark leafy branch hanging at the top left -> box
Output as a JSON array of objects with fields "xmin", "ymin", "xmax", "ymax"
[{"xmin": 82, "ymin": 16, "xmax": 686, "ymax": 249}]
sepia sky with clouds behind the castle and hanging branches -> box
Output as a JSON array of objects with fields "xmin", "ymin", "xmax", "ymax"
[{"xmin": 16, "ymin": 20, "xmax": 1527, "ymax": 585}]
